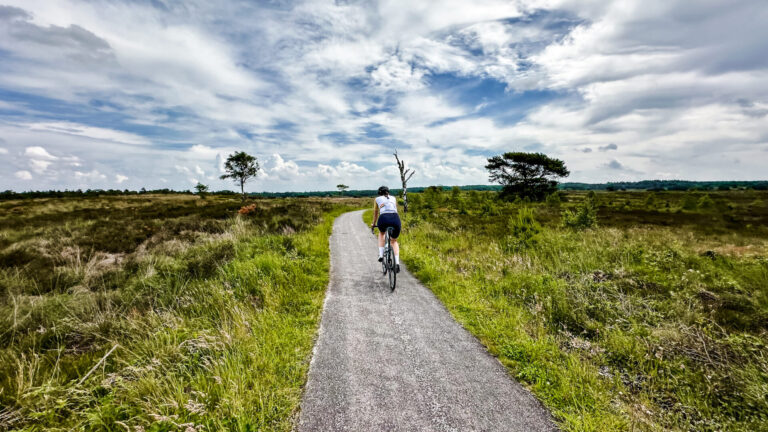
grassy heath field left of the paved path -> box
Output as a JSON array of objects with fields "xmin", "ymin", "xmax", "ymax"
[{"xmin": 0, "ymin": 195, "xmax": 360, "ymax": 431}]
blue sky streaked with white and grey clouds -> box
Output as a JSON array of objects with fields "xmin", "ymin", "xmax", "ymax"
[{"xmin": 0, "ymin": 0, "xmax": 768, "ymax": 191}]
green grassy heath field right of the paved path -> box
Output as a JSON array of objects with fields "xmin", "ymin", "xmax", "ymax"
[{"xmin": 366, "ymin": 190, "xmax": 768, "ymax": 431}]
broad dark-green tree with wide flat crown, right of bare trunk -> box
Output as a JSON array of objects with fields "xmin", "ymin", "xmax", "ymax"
[{"xmin": 485, "ymin": 152, "xmax": 570, "ymax": 201}]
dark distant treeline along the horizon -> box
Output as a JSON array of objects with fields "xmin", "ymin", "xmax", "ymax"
[{"xmin": 0, "ymin": 180, "xmax": 768, "ymax": 200}]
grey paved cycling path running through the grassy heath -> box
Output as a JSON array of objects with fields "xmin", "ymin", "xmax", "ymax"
[{"xmin": 298, "ymin": 211, "xmax": 556, "ymax": 432}]
